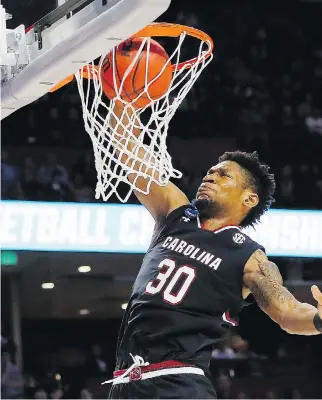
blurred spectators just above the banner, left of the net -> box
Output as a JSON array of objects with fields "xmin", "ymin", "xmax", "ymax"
[{"xmin": 1, "ymin": 149, "xmax": 96, "ymax": 202}]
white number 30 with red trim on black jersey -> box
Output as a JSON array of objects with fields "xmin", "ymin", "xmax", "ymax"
[{"xmin": 145, "ymin": 258, "xmax": 196, "ymax": 305}]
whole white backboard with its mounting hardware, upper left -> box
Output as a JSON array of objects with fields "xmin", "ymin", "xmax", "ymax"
[{"xmin": 0, "ymin": 0, "xmax": 171, "ymax": 119}]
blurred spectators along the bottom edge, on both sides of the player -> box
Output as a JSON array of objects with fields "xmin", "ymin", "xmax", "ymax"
[{"xmin": 1, "ymin": 332, "xmax": 314, "ymax": 399}]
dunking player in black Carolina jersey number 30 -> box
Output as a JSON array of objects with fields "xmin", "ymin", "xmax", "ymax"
[{"xmin": 106, "ymin": 102, "xmax": 322, "ymax": 399}]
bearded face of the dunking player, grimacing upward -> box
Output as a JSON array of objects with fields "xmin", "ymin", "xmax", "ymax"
[{"xmin": 196, "ymin": 161, "xmax": 253, "ymax": 217}]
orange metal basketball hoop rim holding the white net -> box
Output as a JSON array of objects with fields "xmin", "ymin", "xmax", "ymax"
[{"xmin": 49, "ymin": 22, "xmax": 215, "ymax": 93}]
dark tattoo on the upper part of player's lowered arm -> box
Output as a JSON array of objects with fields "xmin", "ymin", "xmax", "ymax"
[{"xmin": 246, "ymin": 250, "xmax": 297, "ymax": 309}]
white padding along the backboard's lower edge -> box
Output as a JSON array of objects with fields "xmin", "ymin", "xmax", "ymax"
[{"xmin": 1, "ymin": 0, "xmax": 171, "ymax": 119}]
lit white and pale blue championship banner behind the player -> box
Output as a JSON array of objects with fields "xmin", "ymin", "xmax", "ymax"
[{"xmin": 0, "ymin": 201, "xmax": 322, "ymax": 258}]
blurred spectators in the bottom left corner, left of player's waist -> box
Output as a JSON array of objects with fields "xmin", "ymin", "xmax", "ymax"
[{"xmin": 1, "ymin": 336, "xmax": 107, "ymax": 399}]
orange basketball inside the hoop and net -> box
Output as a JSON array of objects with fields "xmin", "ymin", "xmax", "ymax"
[{"xmin": 101, "ymin": 37, "xmax": 172, "ymax": 108}]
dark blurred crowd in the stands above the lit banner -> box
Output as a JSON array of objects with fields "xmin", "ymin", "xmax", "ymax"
[{"xmin": 1, "ymin": 0, "xmax": 322, "ymax": 208}]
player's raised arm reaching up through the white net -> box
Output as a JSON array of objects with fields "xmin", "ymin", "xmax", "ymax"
[{"xmin": 110, "ymin": 101, "xmax": 189, "ymax": 220}]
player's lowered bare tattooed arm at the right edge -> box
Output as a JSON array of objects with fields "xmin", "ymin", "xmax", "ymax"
[{"xmin": 244, "ymin": 250, "xmax": 322, "ymax": 335}]
